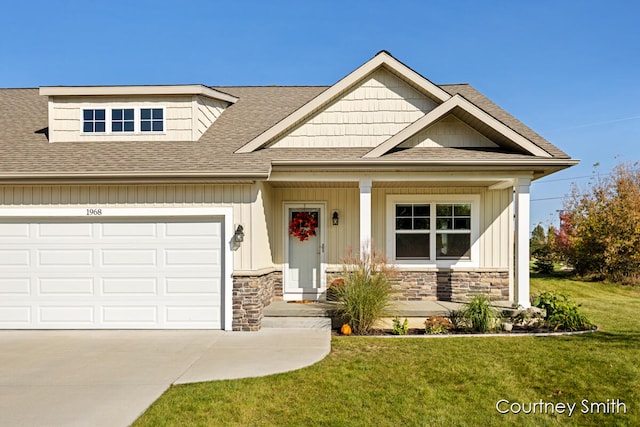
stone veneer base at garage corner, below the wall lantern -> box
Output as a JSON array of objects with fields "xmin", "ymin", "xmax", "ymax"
[{"xmin": 232, "ymin": 271, "xmax": 282, "ymax": 331}]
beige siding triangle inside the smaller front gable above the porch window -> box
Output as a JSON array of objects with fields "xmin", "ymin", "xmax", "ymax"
[{"xmin": 399, "ymin": 116, "xmax": 498, "ymax": 148}]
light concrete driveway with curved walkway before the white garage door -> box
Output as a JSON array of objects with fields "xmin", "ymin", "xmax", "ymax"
[{"xmin": 0, "ymin": 328, "xmax": 331, "ymax": 427}]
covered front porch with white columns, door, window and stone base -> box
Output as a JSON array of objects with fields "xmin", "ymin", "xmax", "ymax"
[{"xmin": 264, "ymin": 170, "xmax": 530, "ymax": 310}]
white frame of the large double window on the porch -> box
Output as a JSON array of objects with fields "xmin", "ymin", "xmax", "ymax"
[{"xmin": 386, "ymin": 194, "xmax": 480, "ymax": 268}]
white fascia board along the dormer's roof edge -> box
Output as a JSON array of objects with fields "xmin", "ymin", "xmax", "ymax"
[{"xmin": 40, "ymin": 85, "xmax": 238, "ymax": 104}]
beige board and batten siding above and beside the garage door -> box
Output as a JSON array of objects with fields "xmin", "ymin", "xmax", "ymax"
[{"xmin": 0, "ymin": 184, "xmax": 273, "ymax": 271}]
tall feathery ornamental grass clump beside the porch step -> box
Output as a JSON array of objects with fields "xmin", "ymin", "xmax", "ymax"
[{"xmin": 334, "ymin": 247, "xmax": 395, "ymax": 335}]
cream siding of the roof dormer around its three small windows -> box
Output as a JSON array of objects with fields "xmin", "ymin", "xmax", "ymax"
[{"xmin": 49, "ymin": 95, "xmax": 228, "ymax": 143}]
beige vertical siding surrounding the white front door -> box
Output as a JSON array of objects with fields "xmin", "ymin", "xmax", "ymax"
[{"xmin": 269, "ymin": 188, "xmax": 360, "ymax": 264}]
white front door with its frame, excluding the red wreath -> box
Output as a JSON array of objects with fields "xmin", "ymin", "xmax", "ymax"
[{"xmin": 284, "ymin": 203, "xmax": 325, "ymax": 300}]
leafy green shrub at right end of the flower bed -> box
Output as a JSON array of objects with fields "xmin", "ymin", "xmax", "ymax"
[{"xmin": 533, "ymin": 291, "xmax": 594, "ymax": 331}]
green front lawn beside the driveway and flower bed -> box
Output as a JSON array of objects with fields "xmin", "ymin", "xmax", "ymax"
[{"xmin": 134, "ymin": 277, "xmax": 640, "ymax": 426}]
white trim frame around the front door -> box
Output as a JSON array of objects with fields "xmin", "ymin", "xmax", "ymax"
[{"xmin": 282, "ymin": 201, "xmax": 327, "ymax": 301}]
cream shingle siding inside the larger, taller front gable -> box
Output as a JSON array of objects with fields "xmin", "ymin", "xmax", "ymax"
[{"xmin": 272, "ymin": 68, "xmax": 436, "ymax": 148}]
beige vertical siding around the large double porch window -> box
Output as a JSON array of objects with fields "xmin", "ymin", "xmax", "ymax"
[{"xmin": 371, "ymin": 187, "xmax": 512, "ymax": 269}]
